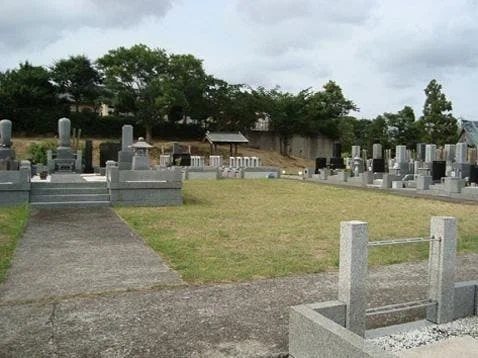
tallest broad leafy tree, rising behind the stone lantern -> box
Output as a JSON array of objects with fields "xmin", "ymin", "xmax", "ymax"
[{"xmin": 97, "ymin": 44, "xmax": 171, "ymax": 141}]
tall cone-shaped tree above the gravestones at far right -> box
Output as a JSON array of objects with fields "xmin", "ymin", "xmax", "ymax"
[{"xmin": 421, "ymin": 79, "xmax": 458, "ymax": 145}]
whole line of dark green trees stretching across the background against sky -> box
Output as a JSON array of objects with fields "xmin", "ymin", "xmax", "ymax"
[{"xmin": 0, "ymin": 44, "xmax": 458, "ymax": 153}]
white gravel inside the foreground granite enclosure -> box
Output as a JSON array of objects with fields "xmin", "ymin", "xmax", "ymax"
[{"xmin": 367, "ymin": 316, "xmax": 478, "ymax": 352}]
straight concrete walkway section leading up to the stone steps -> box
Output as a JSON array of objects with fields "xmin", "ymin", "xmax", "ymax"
[{"xmin": 0, "ymin": 208, "xmax": 181, "ymax": 303}]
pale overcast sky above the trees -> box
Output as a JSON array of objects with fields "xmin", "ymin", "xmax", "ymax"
[{"xmin": 0, "ymin": 0, "xmax": 478, "ymax": 119}]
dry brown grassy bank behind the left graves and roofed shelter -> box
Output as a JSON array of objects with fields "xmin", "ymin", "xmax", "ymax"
[{"xmin": 13, "ymin": 138, "xmax": 314, "ymax": 173}]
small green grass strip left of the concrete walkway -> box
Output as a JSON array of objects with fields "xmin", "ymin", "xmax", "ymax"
[{"xmin": 0, "ymin": 205, "xmax": 28, "ymax": 283}]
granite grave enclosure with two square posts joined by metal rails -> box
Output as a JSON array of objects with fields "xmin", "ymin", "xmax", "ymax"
[{"xmin": 289, "ymin": 217, "xmax": 478, "ymax": 358}]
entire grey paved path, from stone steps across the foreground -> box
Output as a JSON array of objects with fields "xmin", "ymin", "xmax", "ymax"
[{"xmin": 0, "ymin": 209, "xmax": 478, "ymax": 358}]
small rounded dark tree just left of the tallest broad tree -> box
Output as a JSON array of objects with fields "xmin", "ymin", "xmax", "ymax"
[{"xmin": 50, "ymin": 55, "xmax": 102, "ymax": 112}]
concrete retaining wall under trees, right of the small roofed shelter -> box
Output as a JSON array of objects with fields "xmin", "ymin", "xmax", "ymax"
[{"xmin": 246, "ymin": 131, "xmax": 334, "ymax": 160}]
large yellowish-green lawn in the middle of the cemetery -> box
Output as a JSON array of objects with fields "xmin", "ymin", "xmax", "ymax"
[{"xmin": 116, "ymin": 180, "xmax": 478, "ymax": 283}]
